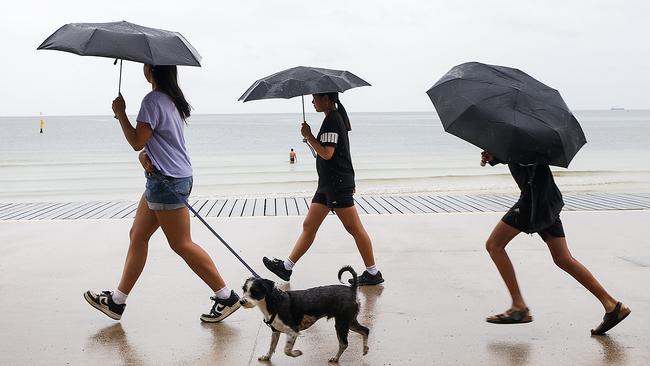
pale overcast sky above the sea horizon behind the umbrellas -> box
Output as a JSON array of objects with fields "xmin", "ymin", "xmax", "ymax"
[{"xmin": 0, "ymin": 0, "xmax": 650, "ymax": 116}]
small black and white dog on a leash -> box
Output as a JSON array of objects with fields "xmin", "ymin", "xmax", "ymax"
[{"xmin": 239, "ymin": 266, "xmax": 370, "ymax": 362}]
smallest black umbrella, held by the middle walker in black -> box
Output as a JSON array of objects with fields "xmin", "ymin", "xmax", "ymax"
[{"xmin": 239, "ymin": 66, "xmax": 370, "ymax": 121}]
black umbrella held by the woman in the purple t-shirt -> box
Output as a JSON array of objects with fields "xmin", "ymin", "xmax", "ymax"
[{"xmin": 37, "ymin": 21, "xmax": 201, "ymax": 92}]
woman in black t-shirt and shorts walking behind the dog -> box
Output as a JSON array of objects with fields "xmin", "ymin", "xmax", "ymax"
[{"xmin": 262, "ymin": 93, "xmax": 384, "ymax": 286}]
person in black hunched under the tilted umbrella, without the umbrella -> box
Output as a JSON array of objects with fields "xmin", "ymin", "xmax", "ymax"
[{"xmin": 481, "ymin": 151, "xmax": 631, "ymax": 335}]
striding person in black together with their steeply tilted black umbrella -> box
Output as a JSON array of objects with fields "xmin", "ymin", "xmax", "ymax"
[{"xmin": 427, "ymin": 62, "xmax": 630, "ymax": 334}]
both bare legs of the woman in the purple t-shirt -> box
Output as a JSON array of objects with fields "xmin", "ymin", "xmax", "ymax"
[{"xmin": 118, "ymin": 197, "xmax": 226, "ymax": 294}]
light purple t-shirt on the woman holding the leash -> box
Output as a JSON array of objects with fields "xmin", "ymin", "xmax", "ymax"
[{"xmin": 136, "ymin": 90, "xmax": 192, "ymax": 178}]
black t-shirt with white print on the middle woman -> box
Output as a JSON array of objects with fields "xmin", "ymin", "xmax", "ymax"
[{"xmin": 316, "ymin": 111, "xmax": 354, "ymax": 193}]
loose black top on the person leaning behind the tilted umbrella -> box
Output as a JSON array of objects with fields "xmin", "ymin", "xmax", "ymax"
[{"xmin": 490, "ymin": 160, "xmax": 564, "ymax": 233}]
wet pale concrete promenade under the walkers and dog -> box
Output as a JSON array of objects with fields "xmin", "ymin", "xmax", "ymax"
[{"xmin": 0, "ymin": 211, "xmax": 650, "ymax": 365}]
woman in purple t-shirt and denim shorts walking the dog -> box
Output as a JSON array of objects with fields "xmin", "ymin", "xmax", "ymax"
[{"xmin": 84, "ymin": 65, "xmax": 240, "ymax": 322}]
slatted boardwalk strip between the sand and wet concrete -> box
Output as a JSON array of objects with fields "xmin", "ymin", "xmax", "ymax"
[{"xmin": 0, "ymin": 192, "xmax": 650, "ymax": 221}]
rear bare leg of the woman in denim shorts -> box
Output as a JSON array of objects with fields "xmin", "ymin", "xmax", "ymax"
[{"xmin": 117, "ymin": 195, "xmax": 159, "ymax": 295}]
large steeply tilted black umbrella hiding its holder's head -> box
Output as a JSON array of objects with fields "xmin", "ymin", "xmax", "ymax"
[{"xmin": 427, "ymin": 62, "xmax": 587, "ymax": 168}]
